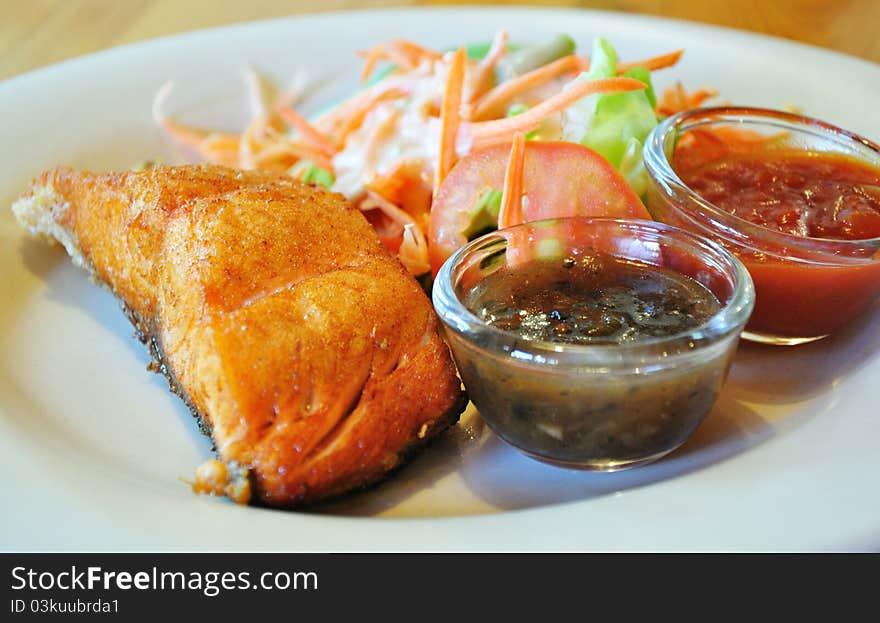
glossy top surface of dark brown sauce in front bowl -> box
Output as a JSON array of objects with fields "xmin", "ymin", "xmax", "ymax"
[{"xmin": 465, "ymin": 253, "xmax": 721, "ymax": 344}]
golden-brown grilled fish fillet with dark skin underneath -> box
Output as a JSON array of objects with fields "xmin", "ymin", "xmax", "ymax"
[{"xmin": 13, "ymin": 166, "xmax": 466, "ymax": 507}]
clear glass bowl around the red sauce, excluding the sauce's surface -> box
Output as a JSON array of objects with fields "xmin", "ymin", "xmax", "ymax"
[{"xmin": 644, "ymin": 107, "xmax": 880, "ymax": 345}]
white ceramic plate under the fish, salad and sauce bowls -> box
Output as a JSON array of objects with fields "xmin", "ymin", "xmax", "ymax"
[{"xmin": 0, "ymin": 8, "xmax": 880, "ymax": 551}]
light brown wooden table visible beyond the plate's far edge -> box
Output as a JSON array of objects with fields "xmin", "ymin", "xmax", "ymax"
[{"xmin": 0, "ymin": 0, "xmax": 880, "ymax": 79}]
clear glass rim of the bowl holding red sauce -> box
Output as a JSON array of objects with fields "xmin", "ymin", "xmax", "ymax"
[{"xmin": 644, "ymin": 106, "xmax": 880, "ymax": 265}]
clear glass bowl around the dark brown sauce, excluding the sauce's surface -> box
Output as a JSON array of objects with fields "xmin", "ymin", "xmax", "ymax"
[{"xmin": 433, "ymin": 218, "xmax": 754, "ymax": 471}]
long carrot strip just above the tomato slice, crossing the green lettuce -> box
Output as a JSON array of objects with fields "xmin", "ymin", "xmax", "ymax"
[{"xmin": 465, "ymin": 78, "xmax": 645, "ymax": 143}]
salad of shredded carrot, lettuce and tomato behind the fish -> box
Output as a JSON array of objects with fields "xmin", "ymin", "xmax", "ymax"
[{"xmin": 153, "ymin": 30, "xmax": 714, "ymax": 276}]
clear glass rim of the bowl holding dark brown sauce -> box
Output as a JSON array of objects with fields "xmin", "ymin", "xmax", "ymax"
[{"xmin": 432, "ymin": 217, "xmax": 755, "ymax": 367}]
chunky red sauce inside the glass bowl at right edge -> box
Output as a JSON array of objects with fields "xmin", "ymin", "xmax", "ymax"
[{"xmin": 674, "ymin": 137, "xmax": 880, "ymax": 337}]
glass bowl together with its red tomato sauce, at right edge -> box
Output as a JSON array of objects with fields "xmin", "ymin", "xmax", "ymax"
[{"xmin": 646, "ymin": 108, "xmax": 880, "ymax": 344}]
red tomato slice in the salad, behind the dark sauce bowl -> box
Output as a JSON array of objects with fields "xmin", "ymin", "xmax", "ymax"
[{"xmin": 429, "ymin": 141, "xmax": 651, "ymax": 275}]
